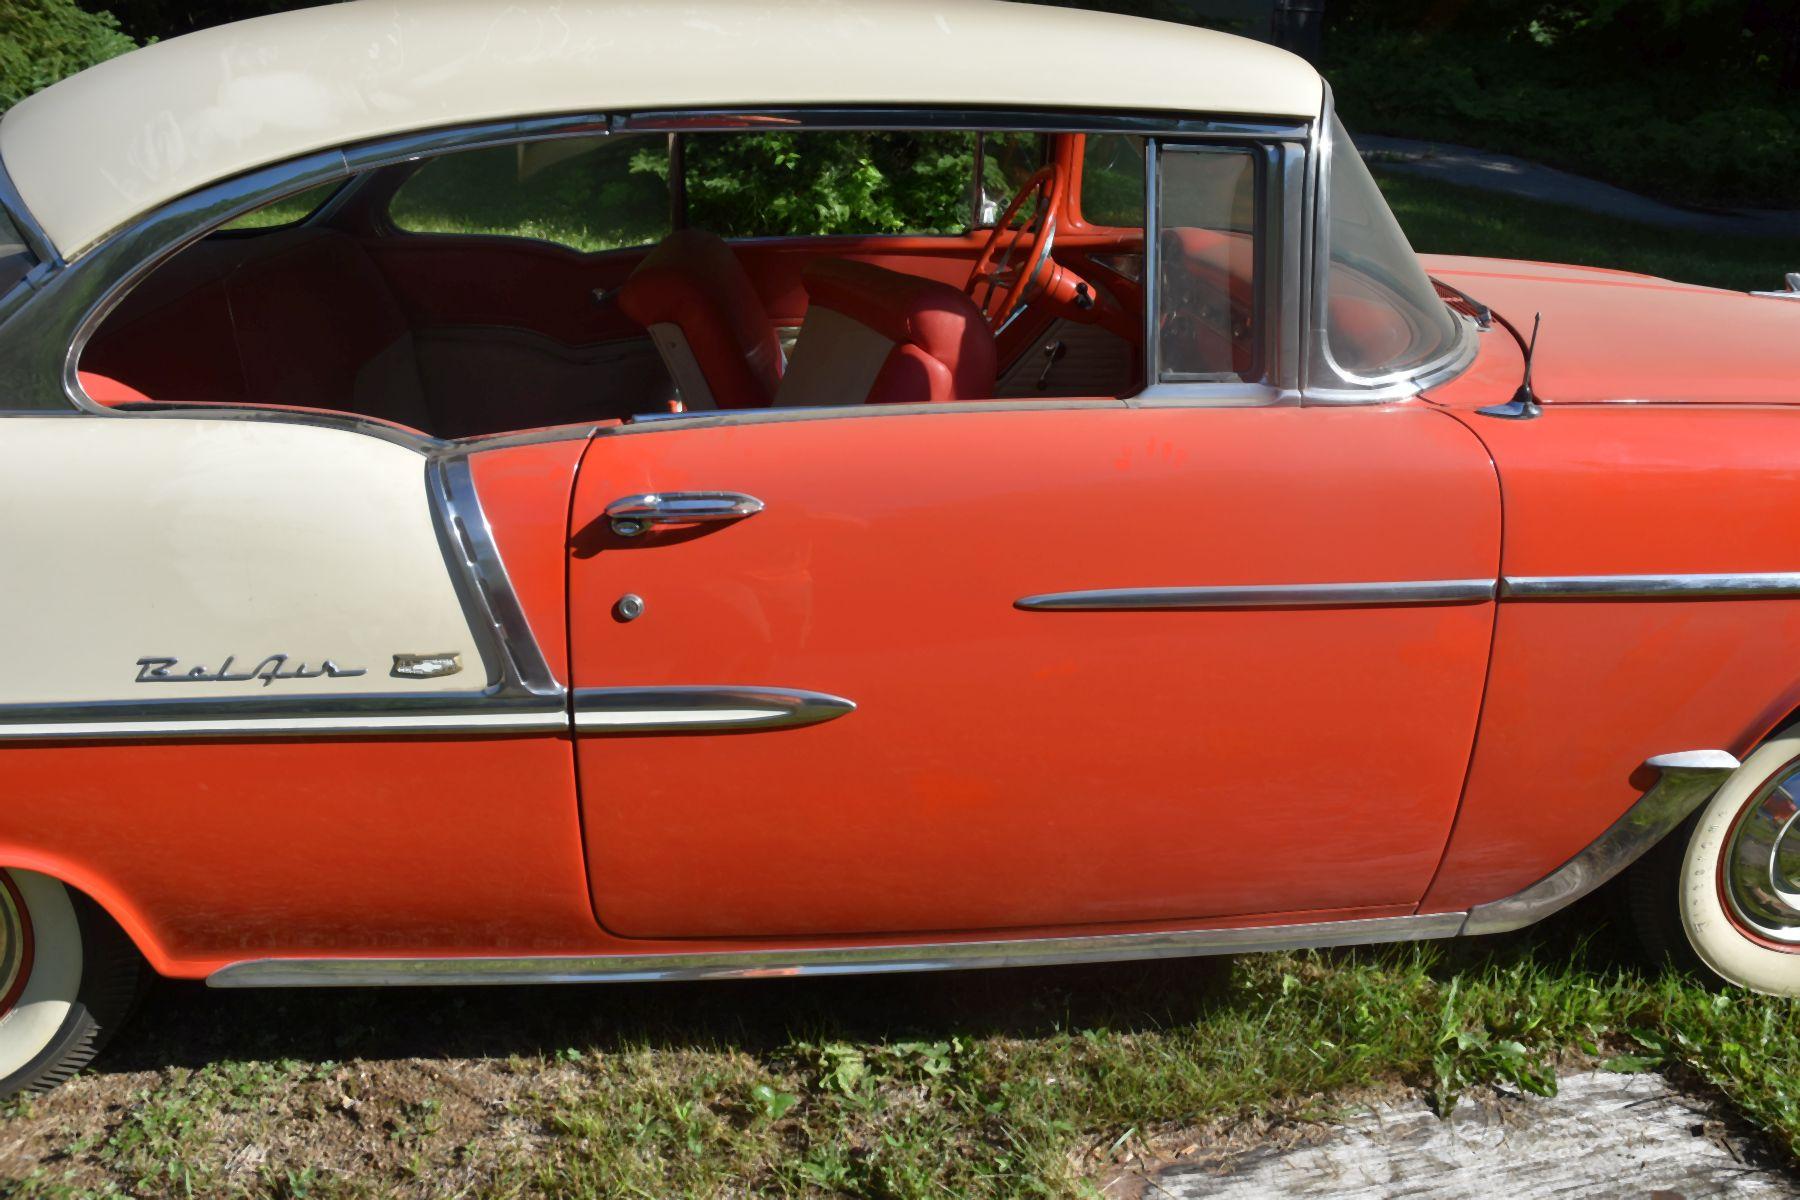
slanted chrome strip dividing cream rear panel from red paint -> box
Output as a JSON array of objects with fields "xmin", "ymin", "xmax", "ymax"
[{"xmin": 425, "ymin": 450, "xmax": 563, "ymax": 700}]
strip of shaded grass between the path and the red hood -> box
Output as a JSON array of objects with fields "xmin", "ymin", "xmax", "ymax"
[{"xmin": 1375, "ymin": 164, "xmax": 1800, "ymax": 291}]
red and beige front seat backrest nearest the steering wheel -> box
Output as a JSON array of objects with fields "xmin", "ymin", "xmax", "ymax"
[{"xmin": 776, "ymin": 259, "xmax": 995, "ymax": 407}]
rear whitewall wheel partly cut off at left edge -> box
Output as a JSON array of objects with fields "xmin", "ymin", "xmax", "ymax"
[{"xmin": 0, "ymin": 871, "xmax": 144, "ymax": 1097}]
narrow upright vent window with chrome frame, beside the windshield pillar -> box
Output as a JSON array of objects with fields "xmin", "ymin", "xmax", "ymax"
[{"xmin": 1157, "ymin": 148, "xmax": 1260, "ymax": 381}]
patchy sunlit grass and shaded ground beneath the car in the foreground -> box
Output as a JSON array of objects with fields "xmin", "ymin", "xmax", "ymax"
[{"xmin": 10, "ymin": 919, "xmax": 1800, "ymax": 1198}]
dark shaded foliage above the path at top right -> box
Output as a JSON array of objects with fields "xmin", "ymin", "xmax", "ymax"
[{"xmin": 1325, "ymin": 0, "xmax": 1800, "ymax": 207}]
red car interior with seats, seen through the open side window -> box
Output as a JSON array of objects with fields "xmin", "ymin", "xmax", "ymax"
[{"xmin": 81, "ymin": 135, "xmax": 1141, "ymax": 437}]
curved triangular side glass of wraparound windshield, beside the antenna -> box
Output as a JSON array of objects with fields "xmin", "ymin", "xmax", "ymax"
[{"xmin": 1325, "ymin": 119, "xmax": 1458, "ymax": 376}]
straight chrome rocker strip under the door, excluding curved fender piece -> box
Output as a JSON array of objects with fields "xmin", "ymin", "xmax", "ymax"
[{"xmin": 207, "ymin": 912, "xmax": 1463, "ymax": 988}]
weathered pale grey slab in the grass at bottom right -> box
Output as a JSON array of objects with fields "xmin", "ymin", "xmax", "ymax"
[{"xmin": 1141, "ymin": 1070, "xmax": 1800, "ymax": 1200}]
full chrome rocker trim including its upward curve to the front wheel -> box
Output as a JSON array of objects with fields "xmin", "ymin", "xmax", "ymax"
[{"xmin": 207, "ymin": 750, "xmax": 1739, "ymax": 988}]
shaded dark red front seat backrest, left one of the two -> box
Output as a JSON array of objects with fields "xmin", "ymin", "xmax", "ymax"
[{"xmin": 619, "ymin": 228, "xmax": 781, "ymax": 412}]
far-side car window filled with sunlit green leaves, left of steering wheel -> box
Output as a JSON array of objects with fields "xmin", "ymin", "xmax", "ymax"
[{"xmin": 682, "ymin": 130, "xmax": 976, "ymax": 237}]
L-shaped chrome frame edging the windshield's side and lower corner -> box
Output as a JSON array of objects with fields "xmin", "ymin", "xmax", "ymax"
[{"xmin": 1300, "ymin": 83, "xmax": 1481, "ymax": 405}]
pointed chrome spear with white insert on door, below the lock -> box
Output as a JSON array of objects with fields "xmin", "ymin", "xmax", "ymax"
[{"xmin": 574, "ymin": 684, "xmax": 857, "ymax": 734}]
